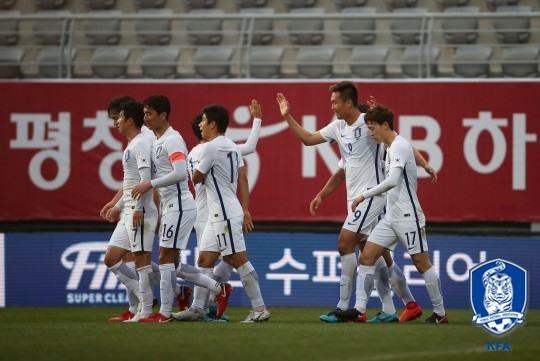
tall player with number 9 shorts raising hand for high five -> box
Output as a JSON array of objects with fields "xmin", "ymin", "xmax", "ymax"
[{"xmin": 276, "ymin": 81, "xmax": 430, "ymax": 322}]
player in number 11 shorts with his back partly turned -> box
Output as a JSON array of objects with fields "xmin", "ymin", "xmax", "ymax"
[{"xmin": 192, "ymin": 104, "xmax": 270, "ymax": 322}]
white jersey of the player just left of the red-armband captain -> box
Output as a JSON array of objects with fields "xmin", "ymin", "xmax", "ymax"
[{"xmin": 122, "ymin": 133, "xmax": 152, "ymax": 208}]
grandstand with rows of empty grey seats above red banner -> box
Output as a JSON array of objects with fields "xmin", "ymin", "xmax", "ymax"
[{"xmin": 0, "ymin": 0, "xmax": 540, "ymax": 79}]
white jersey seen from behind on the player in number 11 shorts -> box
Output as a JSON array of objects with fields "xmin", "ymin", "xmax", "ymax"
[{"xmin": 195, "ymin": 135, "xmax": 244, "ymax": 222}]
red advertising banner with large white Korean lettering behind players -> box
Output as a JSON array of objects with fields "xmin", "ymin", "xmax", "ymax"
[{"xmin": 0, "ymin": 80, "xmax": 540, "ymax": 222}]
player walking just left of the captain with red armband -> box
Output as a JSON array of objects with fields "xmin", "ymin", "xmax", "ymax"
[{"xmin": 105, "ymin": 101, "xmax": 158, "ymax": 322}]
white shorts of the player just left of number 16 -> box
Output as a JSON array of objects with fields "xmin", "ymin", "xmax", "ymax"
[{"xmin": 123, "ymin": 207, "xmax": 158, "ymax": 252}]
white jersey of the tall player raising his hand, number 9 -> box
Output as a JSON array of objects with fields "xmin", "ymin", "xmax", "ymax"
[{"xmin": 320, "ymin": 114, "xmax": 384, "ymax": 201}]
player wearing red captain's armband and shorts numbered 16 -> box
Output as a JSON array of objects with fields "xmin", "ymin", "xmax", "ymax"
[{"xmin": 131, "ymin": 94, "xmax": 232, "ymax": 322}]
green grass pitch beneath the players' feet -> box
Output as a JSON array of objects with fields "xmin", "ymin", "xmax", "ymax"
[{"xmin": 0, "ymin": 307, "xmax": 540, "ymax": 361}]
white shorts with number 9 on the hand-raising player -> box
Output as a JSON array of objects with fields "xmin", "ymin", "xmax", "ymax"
[{"xmin": 342, "ymin": 196, "xmax": 386, "ymax": 236}]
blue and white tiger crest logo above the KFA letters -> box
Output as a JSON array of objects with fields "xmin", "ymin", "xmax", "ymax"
[{"xmin": 470, "ymin": 259, "xmax": 528, "ymax": 335}]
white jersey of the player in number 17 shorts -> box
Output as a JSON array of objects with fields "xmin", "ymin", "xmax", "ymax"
[{"xmin": 386, "ymin": 135, "xmax": 425, "ymax": 225}]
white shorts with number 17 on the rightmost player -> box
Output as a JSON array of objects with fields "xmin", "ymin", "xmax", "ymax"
[{"xmin": 368, "ymin": 215, "xmax": 428, "ymax": 254}]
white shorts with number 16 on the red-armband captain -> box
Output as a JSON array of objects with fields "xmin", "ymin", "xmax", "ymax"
[{"xmin": 159, "ymin": 204, "xmax": 197, "ymax": 249}]
